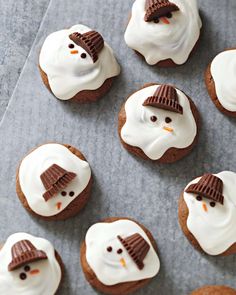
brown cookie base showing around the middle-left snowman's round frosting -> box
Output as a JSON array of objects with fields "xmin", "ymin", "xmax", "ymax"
[{"xmin": 16, "ymin": 144, "xmax": 92, "ymax": 221}]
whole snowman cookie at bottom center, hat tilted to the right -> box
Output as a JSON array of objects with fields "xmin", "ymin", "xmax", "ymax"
[{"xmin": 80, "ymin": 218, "xmax": 160, "ymax": 295}]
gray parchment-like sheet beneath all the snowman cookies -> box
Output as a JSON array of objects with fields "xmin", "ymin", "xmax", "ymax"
[{"xmin": 0, "ymin": 0, "xmax": 236, "ymax": 295}]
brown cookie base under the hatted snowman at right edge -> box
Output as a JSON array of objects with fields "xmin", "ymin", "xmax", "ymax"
[{"xmin": 178, "ymin": 193, "xmax": 236, "ymax": 256}]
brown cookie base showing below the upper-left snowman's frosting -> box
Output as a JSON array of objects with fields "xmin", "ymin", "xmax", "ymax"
[{"xmin": 39, "ymin": 65, "xmax": 115, "ymax": 103}]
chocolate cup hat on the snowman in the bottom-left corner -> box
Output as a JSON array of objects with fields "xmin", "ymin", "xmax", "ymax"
[{"xmin": 8, "ymin": 240, "xmax": 48, "ymax": 271}]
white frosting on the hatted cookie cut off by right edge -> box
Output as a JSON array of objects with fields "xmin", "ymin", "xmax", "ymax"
[{"xmin": 184, "ymin": 171, "xmax": 236, "ymax": 255}]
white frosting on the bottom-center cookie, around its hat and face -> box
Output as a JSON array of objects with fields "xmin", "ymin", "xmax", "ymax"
[{"xmin": 85, "ymin": 220, "xmax": 160, "ymax": 286}]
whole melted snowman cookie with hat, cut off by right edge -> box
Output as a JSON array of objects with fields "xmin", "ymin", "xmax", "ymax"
[{"xmin": 179, "ymin": 171, "xmax": 236, "ymax": 256}]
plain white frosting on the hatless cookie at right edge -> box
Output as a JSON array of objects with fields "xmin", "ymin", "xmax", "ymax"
[{"xmin": 211, "ymin": 49, "xmax": 236, "ymax": 112}]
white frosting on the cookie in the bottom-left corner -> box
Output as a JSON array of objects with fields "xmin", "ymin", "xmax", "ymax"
[{"xmin": 0, "ymin": 233, "xmax": 62, "ymax": 295}]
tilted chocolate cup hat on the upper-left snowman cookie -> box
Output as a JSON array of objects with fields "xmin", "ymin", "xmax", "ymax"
[{"xmin": 69, "ymin": 31, "xmax": 104, "ymax": 63}]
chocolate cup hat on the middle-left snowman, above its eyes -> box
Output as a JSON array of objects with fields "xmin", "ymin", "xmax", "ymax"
[{"xmin": 40, "ymin": 164, "xmax": 76, "ymax": 202}]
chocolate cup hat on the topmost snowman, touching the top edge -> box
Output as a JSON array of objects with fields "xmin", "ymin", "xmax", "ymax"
[{"xmin": 144, "ymin": 0, "xmax": 179, "ymax": 22}]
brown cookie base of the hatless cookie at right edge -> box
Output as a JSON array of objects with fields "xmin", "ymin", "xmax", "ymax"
[{"xmin": 205, "ymin": 48, "xmax": 236, "ymax": 117}]
